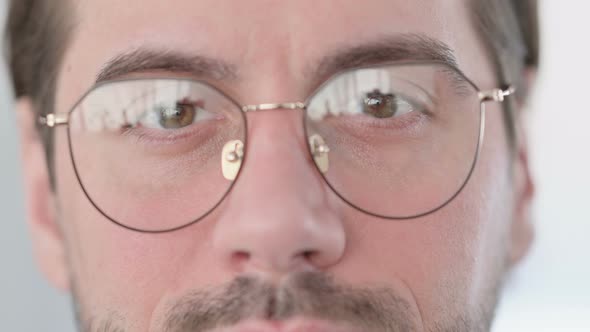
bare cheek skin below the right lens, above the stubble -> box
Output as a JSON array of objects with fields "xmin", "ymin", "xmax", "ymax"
[{"xmin": 334, "ymin": 104, "xmax": 511, "ymax": 319}]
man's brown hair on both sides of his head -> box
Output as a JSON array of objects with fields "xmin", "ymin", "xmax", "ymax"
[{"xmin": 5, "ymin": 0, "xmax": 539, "ymax": 179}]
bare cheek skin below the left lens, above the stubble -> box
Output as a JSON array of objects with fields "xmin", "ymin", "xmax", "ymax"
[{"xmin": 55, "ymin": 130, "xmax": 229, "ymax": 322}]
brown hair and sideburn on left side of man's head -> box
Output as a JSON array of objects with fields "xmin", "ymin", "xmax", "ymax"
[{"xmin": 4, "ymin": 0, "xmax": 72, "ymax": 179}]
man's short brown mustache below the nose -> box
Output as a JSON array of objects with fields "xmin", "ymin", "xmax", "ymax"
[{"xmin": 164, "ymin": 272, "xmax": 416, "ymax": 332}]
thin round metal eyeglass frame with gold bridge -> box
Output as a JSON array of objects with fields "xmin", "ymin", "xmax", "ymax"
[{"xmin": 38, "ymin": 61, "xmax": 515, "ymax": 234}]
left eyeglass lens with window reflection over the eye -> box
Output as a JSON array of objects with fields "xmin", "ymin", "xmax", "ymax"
[{"xmin": 69, "ymin": 79, "xmax": 246, "ymax": 232}]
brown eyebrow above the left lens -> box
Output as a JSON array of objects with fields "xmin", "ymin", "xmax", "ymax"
[{"xmin": 96, "ymin": 48, "xmax": 237, "ymax": 83}]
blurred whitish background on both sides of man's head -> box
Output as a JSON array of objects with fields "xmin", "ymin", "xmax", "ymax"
[{"xmin": 0, "ymin": 0, "xmax": 590, "ymax": 332}]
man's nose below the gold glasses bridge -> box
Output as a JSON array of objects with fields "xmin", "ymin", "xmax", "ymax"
[{"xmin": 213, "ymin": 110, "xmax": 346, "ymax": 278}]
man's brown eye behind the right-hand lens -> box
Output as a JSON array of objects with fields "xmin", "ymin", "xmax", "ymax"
[{"xmin": 361, "ymin": 89, "xmax": 414, "ymax": 119}]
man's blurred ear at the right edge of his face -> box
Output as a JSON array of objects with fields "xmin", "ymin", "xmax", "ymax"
[{"xmin": 510, "ymin": 69, "xmax": 536, "ymax": 266}]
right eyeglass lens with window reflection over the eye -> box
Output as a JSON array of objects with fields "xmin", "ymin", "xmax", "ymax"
[{"xmin": 306, "ymin": 65, "xmax": 481, "ymax": 219}]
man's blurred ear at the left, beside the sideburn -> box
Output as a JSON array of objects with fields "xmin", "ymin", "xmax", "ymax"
[{"xmin": 16, "ymin": 98, "xmax": 69, "ymax": 291}]
